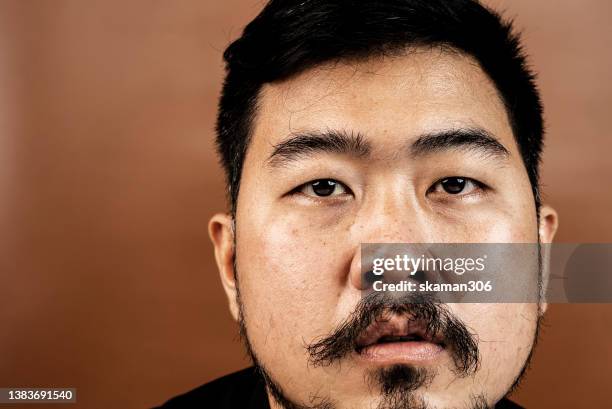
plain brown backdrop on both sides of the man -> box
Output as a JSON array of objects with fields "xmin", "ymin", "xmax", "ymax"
[{"xmin": 0, "ymin": 0, "xmax": 612, "ymax": 408}]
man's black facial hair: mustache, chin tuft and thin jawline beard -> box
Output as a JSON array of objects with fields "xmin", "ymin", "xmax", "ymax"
[{"xmin": 234, "ymin": 246, "xmax": 542, "ymax": 409}]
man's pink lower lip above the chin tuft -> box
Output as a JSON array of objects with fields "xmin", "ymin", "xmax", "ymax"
[{"xmin": 359, "ymin": 341, "xmax": 444, "ymax": 363}]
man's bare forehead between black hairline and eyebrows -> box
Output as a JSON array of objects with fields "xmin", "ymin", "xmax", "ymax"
[{"xmin": 250, "ymin": 48, "xmax": 515, "ymax": 157}]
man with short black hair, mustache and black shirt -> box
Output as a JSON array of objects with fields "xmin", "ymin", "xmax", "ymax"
[{"xmin": 159, "ymin": 0, "xmax": 557, "ymax": 409}]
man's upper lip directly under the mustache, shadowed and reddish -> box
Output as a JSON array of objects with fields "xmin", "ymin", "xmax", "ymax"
[{"xmin": 356, "ymin": 315, "xmax": 442, "ymax": 351}]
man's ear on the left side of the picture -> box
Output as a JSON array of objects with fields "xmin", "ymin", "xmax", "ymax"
[{"xmin": 208, "ymin": 213, "xmax": 238, "ymax": 320}]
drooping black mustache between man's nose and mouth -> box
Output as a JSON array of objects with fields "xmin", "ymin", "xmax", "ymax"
[{"xmin": 306, "ymin": 292, "xmax": 480, "ymax": 376}]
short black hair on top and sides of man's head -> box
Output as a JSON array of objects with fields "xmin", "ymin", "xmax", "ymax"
[{"xmin": 216, "ymin": 0, "xmax": 544, "ymax": 213}]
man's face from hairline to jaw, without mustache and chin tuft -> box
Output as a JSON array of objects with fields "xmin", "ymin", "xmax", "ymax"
[{"xmin": 217, "ymin": 49, "xmax": 548, "ymax": 408}]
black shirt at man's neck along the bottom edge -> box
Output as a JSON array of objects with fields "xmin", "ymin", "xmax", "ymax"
[{"xmin": 158, "ymin": 367, "xmax": 522, "ymax": 409}]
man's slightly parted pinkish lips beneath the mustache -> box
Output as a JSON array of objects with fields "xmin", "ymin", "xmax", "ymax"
[{"xmin": 355, "ymin": 315, "xmax": 445, "ymax": 362}]
